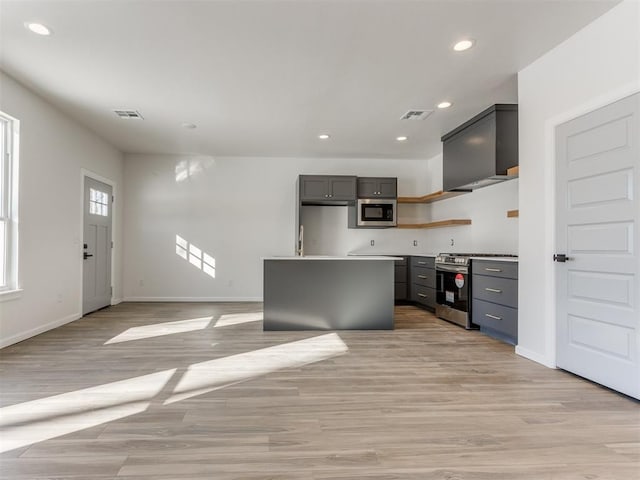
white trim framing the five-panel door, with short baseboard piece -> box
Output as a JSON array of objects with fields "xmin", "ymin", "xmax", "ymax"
[{"xmin": 516, "ymin": 82, "xmax": 640, "ymax": 368}]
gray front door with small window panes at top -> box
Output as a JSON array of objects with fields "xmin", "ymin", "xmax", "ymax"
[{"xmin": 82, "ymin": 177, "xmax": 113, "ymax": 315}]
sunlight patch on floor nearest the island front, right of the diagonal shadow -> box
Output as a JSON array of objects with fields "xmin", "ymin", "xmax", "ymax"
[{"xmin": 164, "ymin": 333, "xmax": 349, "ymax": 405}]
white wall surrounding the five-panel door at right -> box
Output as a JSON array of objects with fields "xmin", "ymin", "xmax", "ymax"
[{"xmin": 516, "ymin": 1, "xmax": 640, "ymax": 366}]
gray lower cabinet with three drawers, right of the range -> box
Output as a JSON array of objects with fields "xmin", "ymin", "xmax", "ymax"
[{"xmin": 471, "ymin": 260, "xmax": 518, "ymax": 345}]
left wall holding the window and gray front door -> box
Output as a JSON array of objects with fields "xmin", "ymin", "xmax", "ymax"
[{"xmin": 0, "ymin": 72, "xmax": 122, "ymax": 346}]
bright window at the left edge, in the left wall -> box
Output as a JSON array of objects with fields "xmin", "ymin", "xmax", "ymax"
[{"xmin": 0, "ymin": 112, "xmax": 18, "ymax": 293}]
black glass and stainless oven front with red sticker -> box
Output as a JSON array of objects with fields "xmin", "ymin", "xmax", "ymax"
[{"xmin": 436, "ymin": 265, "xmax": 472, "ymax": 328}]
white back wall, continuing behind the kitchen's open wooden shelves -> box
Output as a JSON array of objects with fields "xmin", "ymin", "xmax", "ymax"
[{"xmin": 124, "ymin": 155, "xmax": 517, "ymax": 300}]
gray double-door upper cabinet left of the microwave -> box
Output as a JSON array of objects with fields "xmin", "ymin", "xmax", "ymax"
[{"xmin": 299, "ymin": 175, "xmax": 356, "ymax": 205}]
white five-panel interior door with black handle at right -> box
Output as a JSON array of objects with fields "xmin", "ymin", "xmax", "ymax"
[{"xmin": 556, "ymin": 94, "xmax": 640, "ymax": 398}]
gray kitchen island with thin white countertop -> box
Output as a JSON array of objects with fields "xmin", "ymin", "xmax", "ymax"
[{"xmin": 263, "ymin": 256, "xmax": 397, "ymax": 330}]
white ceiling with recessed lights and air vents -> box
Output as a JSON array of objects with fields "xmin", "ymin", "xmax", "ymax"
[{"xmin": 0, "ymin": 0, "xmax": 618, "ymax": 159}]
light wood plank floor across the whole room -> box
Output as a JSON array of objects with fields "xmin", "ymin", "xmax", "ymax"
[{"xmin": 0, "ymin": 303, "xmax": 640, "ymax": 480}]
